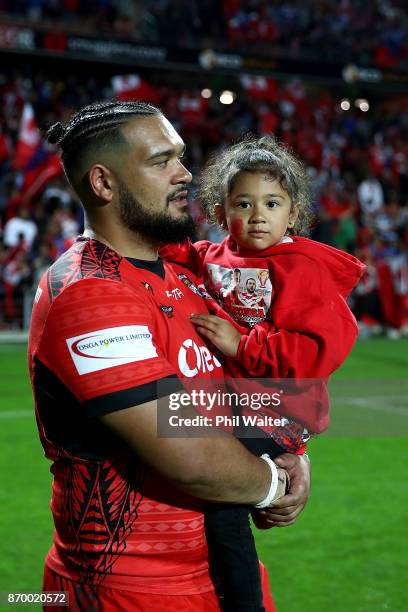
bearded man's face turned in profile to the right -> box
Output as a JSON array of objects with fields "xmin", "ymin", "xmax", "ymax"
[{"xmin": 117, "ymin": 116, "xmax": 194, "ymax": 242}]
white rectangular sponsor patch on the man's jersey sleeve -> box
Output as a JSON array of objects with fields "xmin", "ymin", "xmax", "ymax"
[{"xmin": 66, "ymin": 325, "xmax": 157, "ymax": 375}]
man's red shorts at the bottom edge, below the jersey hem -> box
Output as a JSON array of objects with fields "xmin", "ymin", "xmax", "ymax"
[{"xmin": 43, "ymin": 564, "xmax": 276, "ymax": 612}]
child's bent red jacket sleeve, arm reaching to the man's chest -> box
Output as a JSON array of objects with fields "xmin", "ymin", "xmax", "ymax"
[{"xmin": 236, "ymin": 263, "xmax": 358, "ymax": 378}]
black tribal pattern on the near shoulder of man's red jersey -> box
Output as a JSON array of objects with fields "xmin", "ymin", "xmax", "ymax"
[{"xmin": 47, "ymin": 239, "xmax": 122, "ymax": 302}]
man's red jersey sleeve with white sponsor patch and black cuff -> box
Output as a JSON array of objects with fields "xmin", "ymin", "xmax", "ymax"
[{"xmin": 37, "ymin": 278, "xmax": 178, "ymax": 416}]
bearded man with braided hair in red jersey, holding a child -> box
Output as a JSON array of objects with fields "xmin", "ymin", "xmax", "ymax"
[{"xmin": 29, "ymin": 102, "xmax": 308, "ymax": 612}]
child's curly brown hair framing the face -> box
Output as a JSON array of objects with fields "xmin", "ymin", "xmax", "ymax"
[{"xmin": 198, "ymin": 134, "xmax": 314, "ymax": 236}]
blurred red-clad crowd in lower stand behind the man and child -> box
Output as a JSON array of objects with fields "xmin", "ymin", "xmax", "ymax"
[{"xmin": 0, "ymin": 64, "xmax": 408, "ymax": 337}]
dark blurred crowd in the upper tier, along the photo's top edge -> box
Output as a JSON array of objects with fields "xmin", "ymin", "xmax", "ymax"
[{"xmin": 0, "ymin": 0, "xmax": 408, "ymax": 68}]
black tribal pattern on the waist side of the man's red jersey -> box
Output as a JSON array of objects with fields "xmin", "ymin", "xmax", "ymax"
[{"xmin": 62, "ymin": 455, "xmax": 147, "ymax": 584}]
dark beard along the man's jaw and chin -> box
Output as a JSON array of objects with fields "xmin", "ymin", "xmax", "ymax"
[{"xmin": 119, "ymin": 182, "xmax": 196, "ymax": 244}]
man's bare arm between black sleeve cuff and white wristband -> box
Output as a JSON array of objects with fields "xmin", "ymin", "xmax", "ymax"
[{"xmin": 101, "ymin": 401, "xmax": 271, "ymax": 504}]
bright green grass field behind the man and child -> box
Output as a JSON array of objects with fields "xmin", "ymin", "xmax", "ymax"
[{"xmin": 0, "ymin": 340, "xmax": 408, "ymax": 612}]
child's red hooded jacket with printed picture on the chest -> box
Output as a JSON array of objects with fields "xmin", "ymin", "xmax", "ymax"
[{"xmin": 161, "ymin": 236, "xmax": 364, "ymax": 432}]
